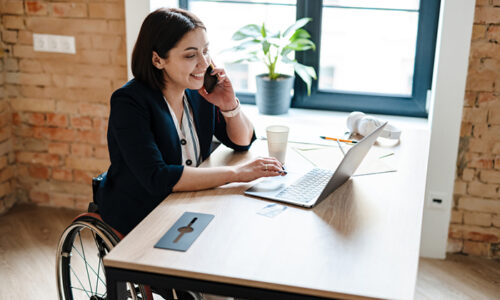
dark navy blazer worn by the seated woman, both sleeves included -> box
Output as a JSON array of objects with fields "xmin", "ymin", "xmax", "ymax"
[{"xmin": 97, "ymin": 79, "xmax": 255, "ymax": 234}]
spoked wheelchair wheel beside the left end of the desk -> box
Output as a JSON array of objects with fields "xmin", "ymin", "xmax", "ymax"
[{"xmin": 56, "ymin": 215, "xmax": 148, "ymax": 300}]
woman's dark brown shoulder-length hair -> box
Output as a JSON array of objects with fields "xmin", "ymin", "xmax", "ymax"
[{"xmin": 132, "ymin": 8, "xmax": 205, "ymax": 90}]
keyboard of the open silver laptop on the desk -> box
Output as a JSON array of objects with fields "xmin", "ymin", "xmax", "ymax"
[{"xmin": 276, "ymin": 168, "xmax": 333, "ymax": 203}]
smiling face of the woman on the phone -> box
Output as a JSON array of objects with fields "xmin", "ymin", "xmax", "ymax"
[{"xmin": 157, "ymin": 28, "xmax": 210, "ymax": 90}]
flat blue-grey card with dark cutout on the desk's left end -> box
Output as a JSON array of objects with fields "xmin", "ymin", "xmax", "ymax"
[{"xmin": 155, "ymin": 212, "xmax": 214, "ymax": 251}]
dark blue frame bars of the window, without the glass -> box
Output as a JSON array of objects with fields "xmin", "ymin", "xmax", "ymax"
[{"xmin": 179, "ymin": 0, "xmax": 441, "ymax": 118}]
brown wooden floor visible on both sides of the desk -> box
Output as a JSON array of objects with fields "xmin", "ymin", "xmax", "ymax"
[{"xmin": 0, "ymin": 205, "xmax": 500, "ymax": 300}]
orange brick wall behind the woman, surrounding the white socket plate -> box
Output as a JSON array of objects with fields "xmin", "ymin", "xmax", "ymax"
[{"xmin": 0, "ymin": 0, "xmax": 127, "ymax": 209}]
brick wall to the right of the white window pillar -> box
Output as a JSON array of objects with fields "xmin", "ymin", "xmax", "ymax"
[{"xmin": 448, "ymin": 0, "xmax": 500, "ymax": 258}]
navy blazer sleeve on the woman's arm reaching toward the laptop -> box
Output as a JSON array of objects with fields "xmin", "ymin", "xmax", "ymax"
[{"xmin": 109, "ymin": 94, "xmax": 184, "ymax": 196}]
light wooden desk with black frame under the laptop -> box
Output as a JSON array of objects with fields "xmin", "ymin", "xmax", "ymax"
[{"xmin": 104, "ymin": 130, "xmax": 428, "ymax": 299}]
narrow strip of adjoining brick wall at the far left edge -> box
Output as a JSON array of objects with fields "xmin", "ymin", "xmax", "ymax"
[{"xmin": 0, "ymin": 3, "xmax": 16, "ymax": 213}]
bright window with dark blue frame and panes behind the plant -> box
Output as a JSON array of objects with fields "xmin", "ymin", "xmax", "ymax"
[{"xmin": 179, "ymin": 0, "xmax": 440, "ymax": 117}]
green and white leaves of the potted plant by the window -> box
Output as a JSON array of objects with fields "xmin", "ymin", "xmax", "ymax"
[{"xmin": 230, "ymin": 18, "xmax": 316, "ymax": 95}]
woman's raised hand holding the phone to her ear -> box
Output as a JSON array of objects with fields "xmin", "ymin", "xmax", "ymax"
[{"xmin": 198, "ymin": 63, "xmax": 237, "ymax": 111}]
